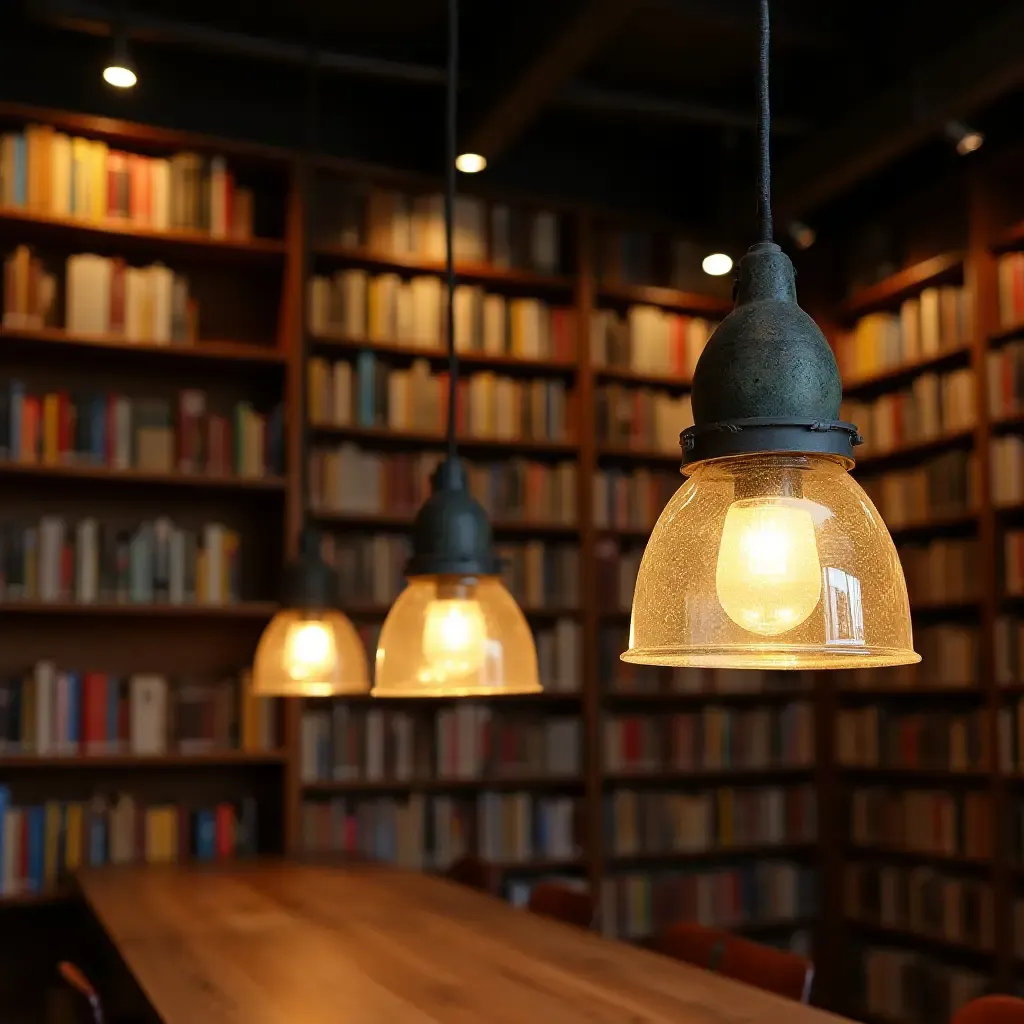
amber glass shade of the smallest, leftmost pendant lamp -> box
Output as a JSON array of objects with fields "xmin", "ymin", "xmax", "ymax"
[{"xmin": 253, "ymin": 608, "xmax": 370, "ymax": 697}]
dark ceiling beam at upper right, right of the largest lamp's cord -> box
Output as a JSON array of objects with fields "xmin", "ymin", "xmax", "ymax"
[{"xmin": 775, "ymin": 2, "xmax": 1024, "ymax": 218}]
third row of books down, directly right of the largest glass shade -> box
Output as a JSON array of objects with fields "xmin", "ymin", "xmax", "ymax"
[{"xmin": 860, "ymin": 450, "xmax": 974, "ymax": 528}]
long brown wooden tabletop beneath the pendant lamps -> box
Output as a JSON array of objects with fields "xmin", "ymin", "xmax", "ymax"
[{"xmin": 79, "ymin": 863, "xmax": 841, "ymax": 1024}]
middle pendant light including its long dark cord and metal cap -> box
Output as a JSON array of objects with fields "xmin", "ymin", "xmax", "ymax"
[{"xmin": 373, "ymin": 0, "xmax": 541, "ymax": 697}]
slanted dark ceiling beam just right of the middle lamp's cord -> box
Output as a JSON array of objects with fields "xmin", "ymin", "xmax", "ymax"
[{"xmin": 463, "ymin": 0, "xmax": 637, "ymax": 160}]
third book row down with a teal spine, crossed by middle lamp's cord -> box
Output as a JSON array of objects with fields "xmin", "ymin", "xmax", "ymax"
[{"xmin": 309, "ymin": 350, "xmax": 569, "ymax": 441}]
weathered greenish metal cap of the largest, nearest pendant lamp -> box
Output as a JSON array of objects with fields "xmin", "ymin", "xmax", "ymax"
[{"xmin": 680, "ymin": 242, "xmax": 860, "ymax": 469}]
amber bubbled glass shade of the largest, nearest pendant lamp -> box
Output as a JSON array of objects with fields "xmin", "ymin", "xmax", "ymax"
[{"xmin": 622, "ymin": 454, "xmax": 921, "ymax": 670}]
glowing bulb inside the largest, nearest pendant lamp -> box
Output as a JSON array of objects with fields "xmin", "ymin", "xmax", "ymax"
[{"xmin": 715, "ymin": 498, "xmax": 821, "ymax": 636}]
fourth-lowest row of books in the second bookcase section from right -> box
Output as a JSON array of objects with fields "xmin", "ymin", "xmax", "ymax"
[{"xmin": 836, "ymin": 706, "xmax": 992, "ymax": 771}]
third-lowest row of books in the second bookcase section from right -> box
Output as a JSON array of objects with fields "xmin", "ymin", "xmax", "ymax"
[{"xmin": 850, "ymin": 785, "xmax": 992, "ymax": 859}]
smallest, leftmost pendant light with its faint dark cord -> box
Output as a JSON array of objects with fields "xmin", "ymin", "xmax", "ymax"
[{"xmin": 252, "ymin": 39, "xmax": 370, "ymax": 697}]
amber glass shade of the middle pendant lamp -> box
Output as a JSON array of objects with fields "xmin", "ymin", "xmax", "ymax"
[{"xmin": 373, "ymin": 575, "xmax": 541, "ymax": 697}]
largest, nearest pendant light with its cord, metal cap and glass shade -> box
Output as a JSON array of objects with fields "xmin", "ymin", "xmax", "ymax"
[{"xmin": 622, "ymin": 0, "xmax": 921, "ymax": 669}]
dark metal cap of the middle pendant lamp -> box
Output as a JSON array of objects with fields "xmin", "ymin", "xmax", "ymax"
[{"xmin": 406, "ymin": 457, "xmax": 501, "ymax": 577}]
